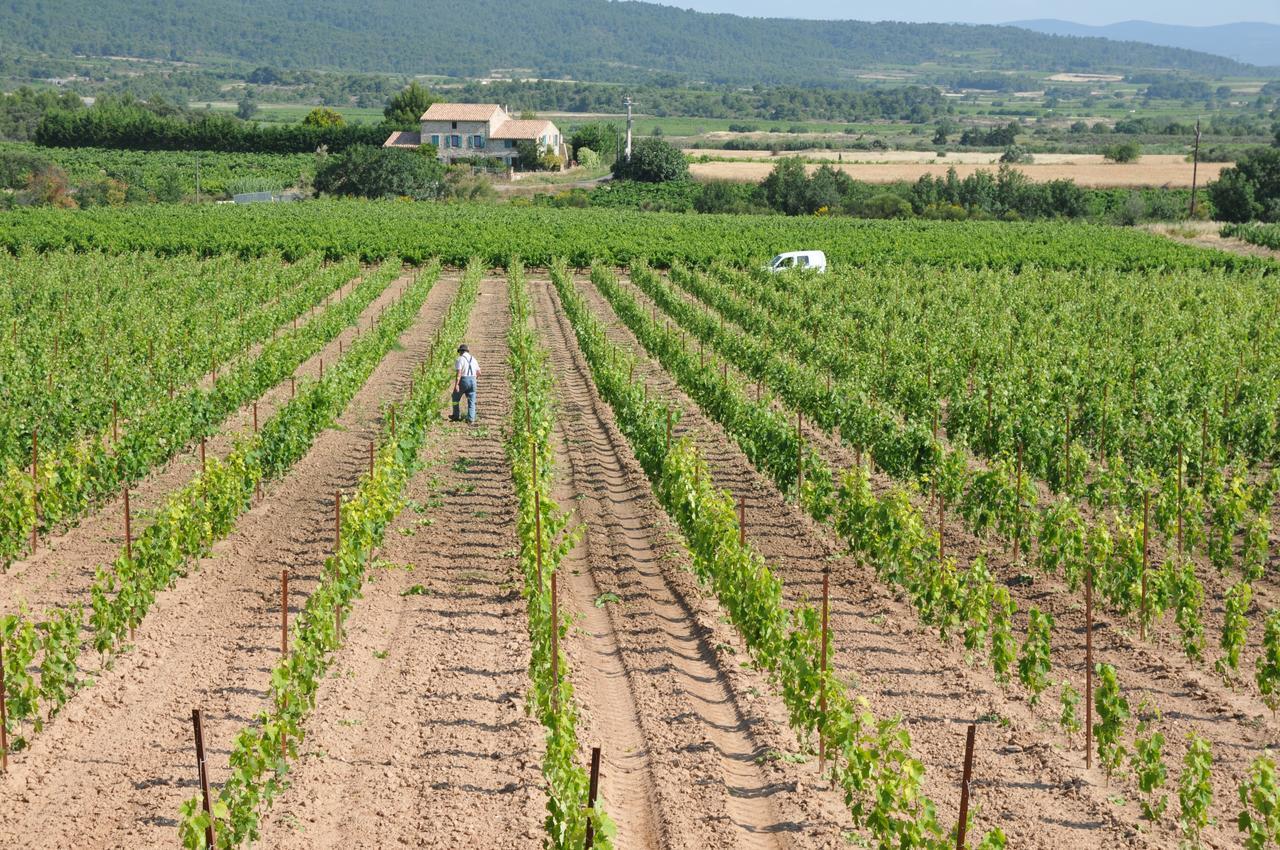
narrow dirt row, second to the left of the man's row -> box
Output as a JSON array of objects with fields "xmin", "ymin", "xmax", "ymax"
[{"xmin": 0, "ymin": 266, "xmax": 401, "ymax": 614}]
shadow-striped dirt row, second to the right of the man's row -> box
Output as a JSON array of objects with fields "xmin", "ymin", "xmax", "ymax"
[{"xmin": 577, "ymin": 272, "xmax": 1175, "ymax": 847}]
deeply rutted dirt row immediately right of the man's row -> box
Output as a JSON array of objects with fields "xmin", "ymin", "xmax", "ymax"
[{"xmin": 531, "ymin": 280, "xmax": 847, "ymax": 847}]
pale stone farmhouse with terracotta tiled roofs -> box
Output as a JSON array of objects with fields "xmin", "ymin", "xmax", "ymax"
[{"xmin": 383, "ymin": 104, "xmax": 568, "ymax": 165}]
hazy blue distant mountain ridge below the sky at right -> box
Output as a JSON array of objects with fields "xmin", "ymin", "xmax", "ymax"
[{"xmin": 1009, "ymin": 18, "xmax": 1280, "ymax": 67}]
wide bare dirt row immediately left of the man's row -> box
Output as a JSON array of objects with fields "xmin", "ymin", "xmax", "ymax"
[{"xmin": 0, "ymin": 274, "xmax": 457, "ymax": 849}]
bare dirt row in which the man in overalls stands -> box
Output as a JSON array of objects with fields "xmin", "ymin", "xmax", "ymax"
[{"xmin": 262, "ymin": 278, "xmax": 545, "ymax": 850}]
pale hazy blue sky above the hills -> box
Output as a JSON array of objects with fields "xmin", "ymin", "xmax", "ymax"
[{"xmin": 658, "ymin": 0, "xmax": 1280, "ymax": 26}]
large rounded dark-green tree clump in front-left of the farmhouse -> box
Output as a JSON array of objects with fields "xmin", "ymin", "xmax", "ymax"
[{"xmin": 315, "ymin": 145, "xmax": 444, "ymax": 201}]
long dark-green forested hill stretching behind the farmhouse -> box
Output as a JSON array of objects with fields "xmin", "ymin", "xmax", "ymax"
[{"xmin": 0, "ymin": 0, "xmax": 1257, "ymax": 83}]
